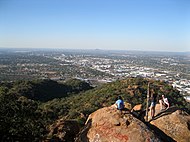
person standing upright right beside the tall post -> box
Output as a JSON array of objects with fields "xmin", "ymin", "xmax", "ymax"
[{"xmin": 150, "ymin": 90, "xmax": 157, "ymax": 119}]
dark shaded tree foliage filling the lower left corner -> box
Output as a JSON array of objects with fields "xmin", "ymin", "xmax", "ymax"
[{"xmin": 0, "ymin": 89, "xmax": 45, "ymax": 141}]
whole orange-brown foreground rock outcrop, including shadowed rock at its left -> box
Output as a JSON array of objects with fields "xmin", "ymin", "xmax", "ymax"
[{"xmin": 47, "ymin": 105, "xmax": 190, "ymax": 142}]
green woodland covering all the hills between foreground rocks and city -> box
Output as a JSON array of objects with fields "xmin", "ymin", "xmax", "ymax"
[{"xmin": 0, "ymin": 78, "xmax": 190, "ymax": 141}]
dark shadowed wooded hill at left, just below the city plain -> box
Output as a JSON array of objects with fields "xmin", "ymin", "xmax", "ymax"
[{"xmin": 1, "ymin": 79, "xmax": 92, "ymax": 102}]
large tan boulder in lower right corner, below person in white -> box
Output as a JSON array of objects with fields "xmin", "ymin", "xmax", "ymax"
[{"xmin": 150, "ymin": 107, "xmax": 190, "ymax": 142}]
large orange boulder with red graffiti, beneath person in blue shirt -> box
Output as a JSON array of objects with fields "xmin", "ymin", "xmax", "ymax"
[{"xmin": 76, "ymin": 106, "xmax": 161, "ymax": 142}]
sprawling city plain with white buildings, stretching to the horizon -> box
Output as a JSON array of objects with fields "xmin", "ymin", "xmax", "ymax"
[{"xmin": 0, "ymin": 48, "xmax": 190, "ymax": 101}]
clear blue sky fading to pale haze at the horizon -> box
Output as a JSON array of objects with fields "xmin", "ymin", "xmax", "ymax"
[{"xmin": 0, "ymin": 0, "xmax": 190, "ymax": 52}]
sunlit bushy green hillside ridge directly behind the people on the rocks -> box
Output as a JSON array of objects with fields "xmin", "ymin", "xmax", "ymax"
[{"xmin": 41, "ymin": 78, "xmax": 190, "ymax": 120}]
